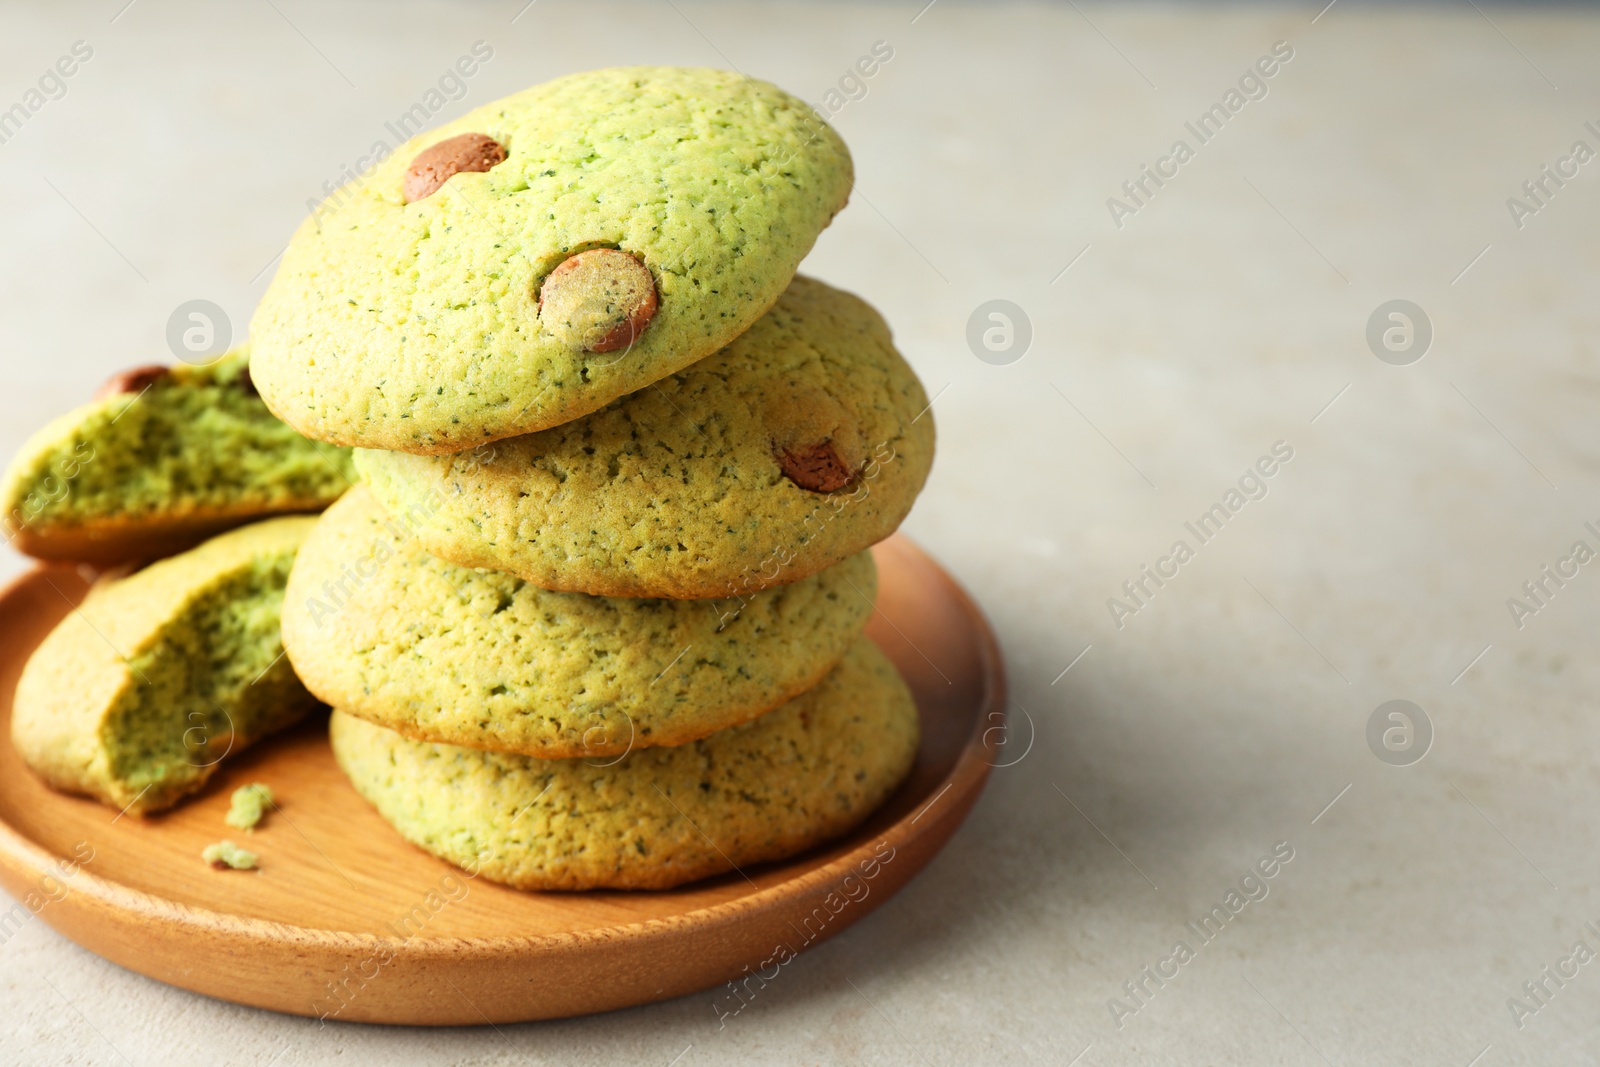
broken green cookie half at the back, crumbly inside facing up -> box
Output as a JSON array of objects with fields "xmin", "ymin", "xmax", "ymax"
[{"xmin": 0, "ymin": 350, "xmax": 354, "ymax": 565}]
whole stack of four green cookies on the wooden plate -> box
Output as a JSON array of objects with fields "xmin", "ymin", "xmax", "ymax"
[{"xmin": 250, "ymin": 69, "xmax": 933, "ymax": 889}]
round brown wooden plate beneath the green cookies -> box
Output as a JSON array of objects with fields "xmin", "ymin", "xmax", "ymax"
[{"xmin": 0, "ymin": 537, "xmax": 1005, "ymax": 1025}]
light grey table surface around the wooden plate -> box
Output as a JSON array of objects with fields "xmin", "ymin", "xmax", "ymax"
[{"xmin": 0, "ymin": 0, "xmax": 1600, "ymax": 1067}]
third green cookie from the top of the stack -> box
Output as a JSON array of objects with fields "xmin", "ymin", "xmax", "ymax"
[{"xmin": 283, "ymin": 486, "xmax": 877, "ymax": 758}]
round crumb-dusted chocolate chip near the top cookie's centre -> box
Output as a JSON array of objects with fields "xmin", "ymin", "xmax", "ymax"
[{"xmin": 539, "ymin": 248, "xmax": 658, "ymax": 352}]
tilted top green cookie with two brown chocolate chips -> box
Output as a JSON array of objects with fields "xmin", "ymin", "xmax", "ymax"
[{"xmin": 251, "ymin": 67, "xmax": 851, "ymax": 454}]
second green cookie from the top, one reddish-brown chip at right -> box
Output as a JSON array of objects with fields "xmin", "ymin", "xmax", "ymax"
[{"xmin": 355, "ymin": 277, "xmax": 934, "ymax": 597}]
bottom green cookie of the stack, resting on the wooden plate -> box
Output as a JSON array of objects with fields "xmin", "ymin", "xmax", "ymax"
[{"xmin": 331, "ymin": 638, "xmax": 918, "ymax": 889}]
